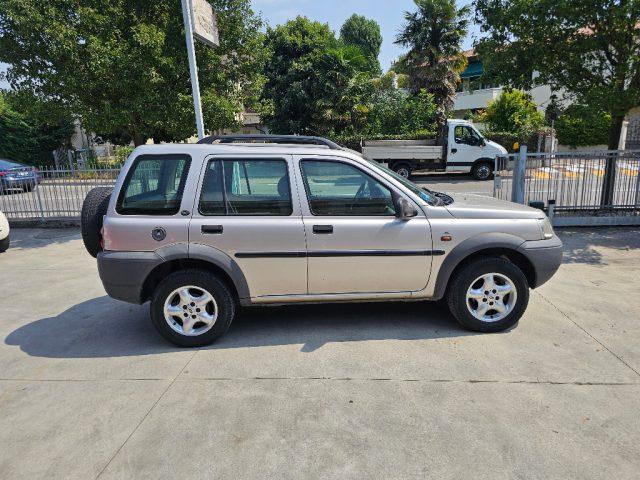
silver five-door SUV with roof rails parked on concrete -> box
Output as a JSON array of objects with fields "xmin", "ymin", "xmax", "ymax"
[{"xmin": 82, "ymin": 137, "xmax": 562, "ymax": 347}]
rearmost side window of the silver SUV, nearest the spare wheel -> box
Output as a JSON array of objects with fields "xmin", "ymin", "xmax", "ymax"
[{"xmin": 116, "ymin": 155, "xmax": 191, "ymax": 215}]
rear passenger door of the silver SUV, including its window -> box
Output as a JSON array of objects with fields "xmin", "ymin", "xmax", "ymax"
[{"xmin": 189, "ymin": 155, "xmax": 307, "ymax": 298}]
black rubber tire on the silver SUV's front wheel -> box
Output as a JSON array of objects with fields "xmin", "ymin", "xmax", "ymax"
[{"xmin": 447, "ymin": 257, "xmax": 529, "ymax": 333}]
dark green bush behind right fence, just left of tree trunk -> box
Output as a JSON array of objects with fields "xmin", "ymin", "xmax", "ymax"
[{"xmin": 555, "ymin": 105, "xmax": 612, "ymax": 148}]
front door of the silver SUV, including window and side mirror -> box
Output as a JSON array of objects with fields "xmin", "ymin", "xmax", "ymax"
[{"xmin": 296, "ymin": 157, "xmax": 432, "ymax": 295}]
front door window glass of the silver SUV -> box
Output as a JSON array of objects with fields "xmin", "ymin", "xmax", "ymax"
[{"xmin": 300, "ymin": 160, "xmax": 395, "ymax": 216}]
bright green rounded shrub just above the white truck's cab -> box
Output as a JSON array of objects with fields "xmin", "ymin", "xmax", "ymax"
[{"xmin": 480, "ymin": 90, "xmax": 544, "ymax": 141}]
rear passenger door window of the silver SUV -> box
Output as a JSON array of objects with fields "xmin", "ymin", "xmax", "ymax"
[{"xmin": 199, "ymin": 159, "xmax": 293, "ymax": 216}]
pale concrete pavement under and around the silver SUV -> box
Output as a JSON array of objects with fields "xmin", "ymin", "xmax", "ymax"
[{"xmin": 0, "ymin": 230, "xmax": 640, "ymax": 480}]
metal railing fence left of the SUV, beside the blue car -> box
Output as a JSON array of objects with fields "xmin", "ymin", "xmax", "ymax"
[{"xmin": 0, "ymin": 167, "xmax": 120, "ymax": 220}]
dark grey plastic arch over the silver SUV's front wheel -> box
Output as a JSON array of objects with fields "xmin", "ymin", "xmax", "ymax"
[{"xmin": 434, "ymin": 233, "xmax": 536, "ymax": 299}]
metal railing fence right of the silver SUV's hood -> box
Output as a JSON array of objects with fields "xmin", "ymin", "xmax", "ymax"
[{"xmin": 494, "ymin": 150, "xmax": 640, "ymax": 223}]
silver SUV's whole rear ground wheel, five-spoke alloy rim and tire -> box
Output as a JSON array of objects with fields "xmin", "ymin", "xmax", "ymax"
[{"xmin": 151, "ymin": 269, "xmax": 235, "ymax": 347}]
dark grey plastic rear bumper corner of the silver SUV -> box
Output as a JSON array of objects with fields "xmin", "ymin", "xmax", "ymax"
[{"xmin": 98, "ymin": 251, "xmax": 163, "ymax": 304}]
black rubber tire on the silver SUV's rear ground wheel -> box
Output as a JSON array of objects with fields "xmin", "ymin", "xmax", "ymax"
[{"xmin": 150, "ymin": 269, "xmax": 235, "ymax": 347}]
